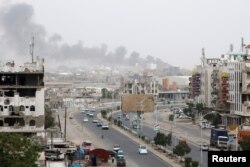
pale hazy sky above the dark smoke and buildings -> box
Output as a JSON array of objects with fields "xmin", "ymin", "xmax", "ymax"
[{"xmin": 0, "ymin": 0, "xmax": 250, "ymax": 69}]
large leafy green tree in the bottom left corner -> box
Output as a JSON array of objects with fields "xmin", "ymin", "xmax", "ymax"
[{"xmin": 0, "ymin": 133, "xmax": 40, "ymax": 167}]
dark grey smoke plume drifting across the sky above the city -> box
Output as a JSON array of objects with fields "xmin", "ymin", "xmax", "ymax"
[{"xmin": 0, "ymin": 3, "xmax": 169, "ymax": 68}]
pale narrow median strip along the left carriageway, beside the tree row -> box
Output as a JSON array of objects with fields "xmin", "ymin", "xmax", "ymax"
[{"xmin": 97, "ymin": 112, "xmax": 181, "ymax": 167}]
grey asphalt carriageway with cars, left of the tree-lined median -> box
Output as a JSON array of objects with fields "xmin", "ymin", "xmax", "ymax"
[{"xmin": 74, "ymin": 111, "xmax": 172, "ymax": 167}]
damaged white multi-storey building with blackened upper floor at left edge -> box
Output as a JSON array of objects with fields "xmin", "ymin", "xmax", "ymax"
[{"xmin": 0, "ymin": 58, "xmax": 44, "ymax": 133}]
